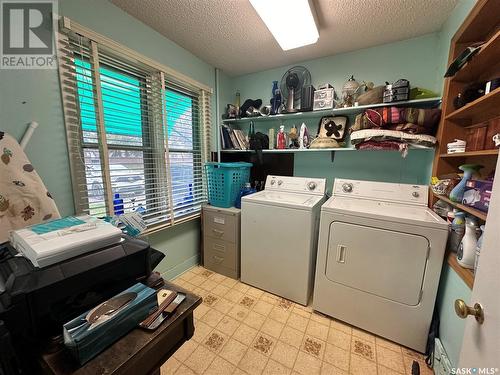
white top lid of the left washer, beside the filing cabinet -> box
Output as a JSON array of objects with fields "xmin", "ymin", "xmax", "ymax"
[{"xmin": 241, "ymin": 190, "xmax": 323, "ymax": 210}]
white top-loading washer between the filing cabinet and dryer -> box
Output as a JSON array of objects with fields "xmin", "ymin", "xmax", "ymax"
[{"xmin": 241, "ymin": 176, "xmax": 326, "ymax": 305}]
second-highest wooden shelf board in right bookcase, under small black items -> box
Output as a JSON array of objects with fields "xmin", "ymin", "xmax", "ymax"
[{"xmin": 446, "ymin": 87, "xmax": 500, "ymax": 123}]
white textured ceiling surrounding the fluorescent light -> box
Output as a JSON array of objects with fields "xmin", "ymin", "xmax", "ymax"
[{"xmin": 111, "ymin": 0, "xmax": 458, "ymax": 76}]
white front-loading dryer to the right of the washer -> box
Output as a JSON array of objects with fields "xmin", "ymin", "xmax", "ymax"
[{"xmin": 313, "ymin": 179, "xmax": 448, "ymax": 353}]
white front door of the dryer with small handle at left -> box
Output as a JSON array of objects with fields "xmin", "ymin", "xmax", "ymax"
[{"xmin": 325, "ymin": 222, "xmax": 429, "ymax": 306}]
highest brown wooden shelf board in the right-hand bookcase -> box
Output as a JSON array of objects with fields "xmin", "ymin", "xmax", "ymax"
[{"xmin": 452, "ymin": 30, "xmax": 500, "ymax": 82}]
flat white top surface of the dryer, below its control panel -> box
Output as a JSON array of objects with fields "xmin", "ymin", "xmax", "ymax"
[{"xmin": 321, "ymin": 197, "xmax": 448, "ymax": 229}]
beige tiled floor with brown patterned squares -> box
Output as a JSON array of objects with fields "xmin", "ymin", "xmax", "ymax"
[{"xmin": 161, "ymin": 267, "xmax": 432, "ymax": 375}]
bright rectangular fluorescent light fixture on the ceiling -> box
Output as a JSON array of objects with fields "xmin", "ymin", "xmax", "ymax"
[{"xmin": 250, "ymin": 0, "xmax": 319, "ymax": 51}]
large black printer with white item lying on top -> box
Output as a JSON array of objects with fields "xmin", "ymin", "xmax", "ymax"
[{"xmin": 0, "ymin": 236, "xmax": 165, "ymax": 374}]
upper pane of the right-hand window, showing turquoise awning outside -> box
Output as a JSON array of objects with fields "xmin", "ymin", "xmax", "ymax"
[{"xmin": 166, "ymin": 90, "xmax": 193, "ymax": 150}]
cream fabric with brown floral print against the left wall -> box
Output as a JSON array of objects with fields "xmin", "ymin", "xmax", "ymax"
[{"xmin": 0, "ymin": 131, "xmax": 61, "ymax": 243}]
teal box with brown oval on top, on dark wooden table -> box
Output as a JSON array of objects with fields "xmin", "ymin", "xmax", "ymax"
[{"xmin": 63, "ymin": 283, "xmax": 157, "ymax": 365}]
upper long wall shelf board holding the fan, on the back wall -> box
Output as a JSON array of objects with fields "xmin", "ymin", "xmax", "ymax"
[{"xmin": 222, "ymin": 97, "xmax": 441, "ymax": 124}]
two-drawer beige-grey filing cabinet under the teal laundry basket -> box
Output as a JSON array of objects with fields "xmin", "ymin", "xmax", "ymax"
[{"xmin": 203, "ymin": 205, "xmax": 241, "ymax": 279}]
